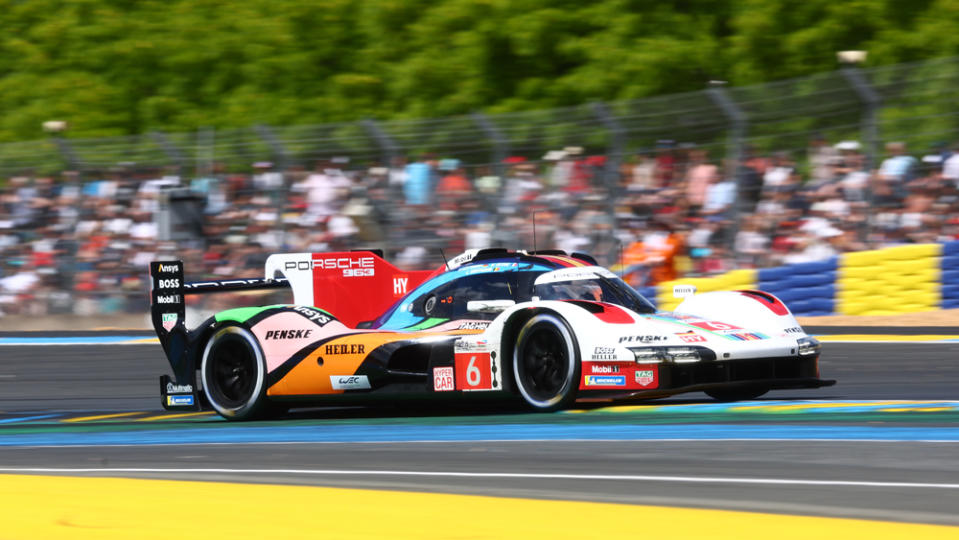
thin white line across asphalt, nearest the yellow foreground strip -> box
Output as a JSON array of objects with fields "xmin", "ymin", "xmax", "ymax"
[{"xmin": 0, "ymin": 467, "xmax": 959, "ymax": 489}]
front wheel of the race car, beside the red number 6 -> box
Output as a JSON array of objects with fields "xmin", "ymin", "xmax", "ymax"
[{"xmin": 513, "ymin": 313, "xmax": 581, "ymax": 411}]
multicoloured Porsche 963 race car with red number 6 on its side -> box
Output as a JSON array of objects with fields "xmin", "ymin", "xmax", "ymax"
[{"xmin": 150, "ymin": 249, "xmax": 835, "ymax": 420}]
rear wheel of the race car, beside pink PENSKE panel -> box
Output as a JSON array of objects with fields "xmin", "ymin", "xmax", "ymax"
[{"xmin": 200, "ymin": 326, "xmax": 267, "ymax": 420}]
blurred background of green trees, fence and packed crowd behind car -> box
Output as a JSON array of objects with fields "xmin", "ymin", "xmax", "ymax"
[{"xmin": 0, "ymin": 0, "xmax": 959, "ymax": 328}]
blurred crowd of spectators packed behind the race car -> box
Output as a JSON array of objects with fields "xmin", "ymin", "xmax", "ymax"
[{"xmin": 0, "ymin": 138, "xmax": 959, "ymax": 316}]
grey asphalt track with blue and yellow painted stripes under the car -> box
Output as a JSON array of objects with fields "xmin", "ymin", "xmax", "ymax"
[{"xmin": 0, "ymin": 329, "xmax": 959, "ymax": 525}]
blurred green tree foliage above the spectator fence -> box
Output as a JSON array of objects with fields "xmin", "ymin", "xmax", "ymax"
[{"xmin": 0, "ymin": 0, "xmax": 959, "ymax": 141}]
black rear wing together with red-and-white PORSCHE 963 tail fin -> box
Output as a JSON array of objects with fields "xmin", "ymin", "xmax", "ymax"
[{"xmin": 150, "ymin": 251, "xmax": 433, "ymax": 410}]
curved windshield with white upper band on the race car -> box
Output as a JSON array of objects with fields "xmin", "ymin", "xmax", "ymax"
[{"xmin": 533, "ymin": 266, "xmax": 656, "ymax": 313}]
